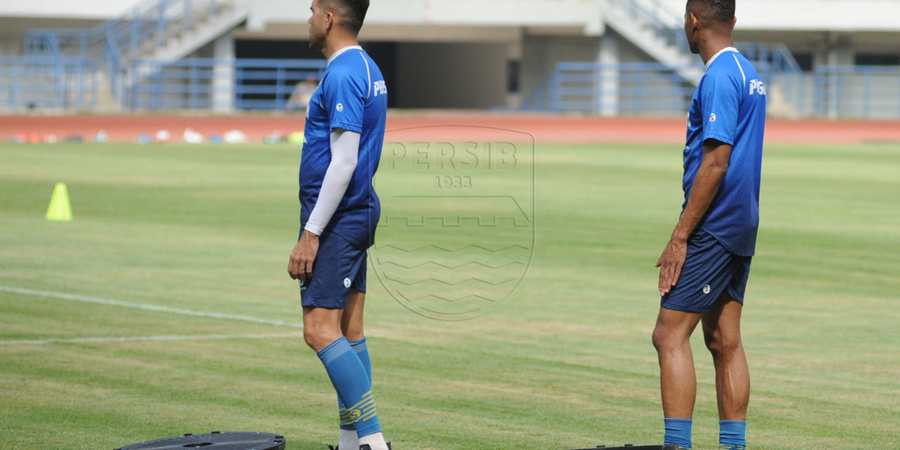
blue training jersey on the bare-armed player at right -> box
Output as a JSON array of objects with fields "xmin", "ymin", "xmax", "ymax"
[{"xmin": 682, "ymin": 47, "xmax": 766, "ymax": 256}]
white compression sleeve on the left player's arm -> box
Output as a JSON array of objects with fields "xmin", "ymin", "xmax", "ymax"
[{"xmin": 304, "ymin": 128, "xmax": 360, "ymax": 235}]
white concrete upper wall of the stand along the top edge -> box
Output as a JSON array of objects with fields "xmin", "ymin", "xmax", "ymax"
[{"xmin": 0, "ymin": 0, "xmax": 900, "ymax": 35}]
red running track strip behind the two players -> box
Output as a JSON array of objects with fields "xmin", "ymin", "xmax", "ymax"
[{"xmin": 0, "ymin": 112, "xmax": 900, "ymax": 144}]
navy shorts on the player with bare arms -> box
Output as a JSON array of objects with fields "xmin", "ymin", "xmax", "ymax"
[{"xmin": 660, "ymin": 231, "xmax": 753, "ymax": 313}]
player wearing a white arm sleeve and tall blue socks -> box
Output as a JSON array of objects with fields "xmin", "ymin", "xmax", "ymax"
[{"xmin": 288, "ymin": 0, "xmax": 389, "ymax": 450}]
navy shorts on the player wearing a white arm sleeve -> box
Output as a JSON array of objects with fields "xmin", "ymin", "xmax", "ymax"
[{"xmin": 300, "ymin": 233, "xmax": 368, "ymax": 309}]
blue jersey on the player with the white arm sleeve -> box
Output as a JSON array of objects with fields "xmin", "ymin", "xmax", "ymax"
[{"xmin": 300, "ymin": 47, "xmax": 387, "ymax": 249}]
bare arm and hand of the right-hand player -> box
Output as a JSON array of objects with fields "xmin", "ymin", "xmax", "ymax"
[{"xmin": 656, "ymin": 139, "xmax": 731, "ymax": 296}]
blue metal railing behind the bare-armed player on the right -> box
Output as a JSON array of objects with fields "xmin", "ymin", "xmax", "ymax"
[{"xmin": 523, "ymin": 62, "xmax": 900, "ymax": 119}]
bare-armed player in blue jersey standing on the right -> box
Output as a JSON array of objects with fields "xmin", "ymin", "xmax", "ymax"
[{"xmin": 653, "ymin": 0, "xmax": 766, "ymax": 450}]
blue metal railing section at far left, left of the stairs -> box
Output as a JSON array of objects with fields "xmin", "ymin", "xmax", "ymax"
[{"xmin": 0, "ymin": 57, "xmax": 97, "ymax": 109}]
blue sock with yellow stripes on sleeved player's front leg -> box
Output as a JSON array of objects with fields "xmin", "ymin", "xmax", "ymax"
[{"xmin": 318, "ymin": 337, "xmax": 381, "ymax": 437}]
